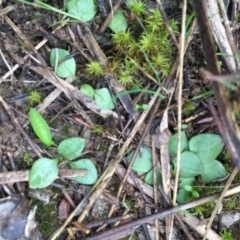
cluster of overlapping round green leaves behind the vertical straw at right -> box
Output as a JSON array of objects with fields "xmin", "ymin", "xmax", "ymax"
[{"xmin": 169, "ymin": 132, "xmax": 227, "ymax": 203}]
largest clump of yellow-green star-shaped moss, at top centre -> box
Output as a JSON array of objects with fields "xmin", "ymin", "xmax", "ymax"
[{"xmin": 113, "ymin": 10, "xmax": 178, "ymax": 87}]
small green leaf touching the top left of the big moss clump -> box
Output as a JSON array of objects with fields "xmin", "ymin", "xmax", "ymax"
[{"xmin": 108, "ymin": 9, "xmax": 128, "ymax": 33}]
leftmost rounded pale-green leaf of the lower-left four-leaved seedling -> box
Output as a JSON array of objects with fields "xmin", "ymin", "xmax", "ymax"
[{"xmin": 29, "ymin": 158, "xmax": 58, "ymax": 189}]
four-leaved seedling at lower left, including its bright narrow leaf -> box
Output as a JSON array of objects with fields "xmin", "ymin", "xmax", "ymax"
[{"xmin": 29, "ymin": 108, "xmax": 98, "ymax": 189}]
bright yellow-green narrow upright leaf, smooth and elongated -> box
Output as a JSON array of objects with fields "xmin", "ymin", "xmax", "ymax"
[{"xmin": 29, "ymin": 108, "xmax": 52, "ymax": 146}]
